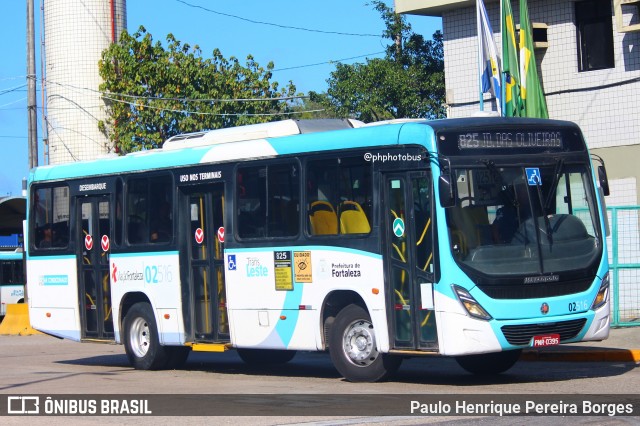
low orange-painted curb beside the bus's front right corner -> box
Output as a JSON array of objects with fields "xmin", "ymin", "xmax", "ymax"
[{"xmin": 520, "ymin": 348, "xmax": 640, "ymax": 364}]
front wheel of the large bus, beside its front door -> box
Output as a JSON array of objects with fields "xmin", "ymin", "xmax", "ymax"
[{"xmin": 329, "ymin": 305, "xmax": 402, "ymax": 382}]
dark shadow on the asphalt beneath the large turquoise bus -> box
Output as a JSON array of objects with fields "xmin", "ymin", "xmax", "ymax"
[{"xmin": 58, "ymin": 351, "xmax": 637, "ymax": 386}]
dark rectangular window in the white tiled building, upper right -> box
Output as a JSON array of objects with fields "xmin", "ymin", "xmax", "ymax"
[{"xmin": 575, "ymin": 0, "xmax": 615, "ymax": 71}]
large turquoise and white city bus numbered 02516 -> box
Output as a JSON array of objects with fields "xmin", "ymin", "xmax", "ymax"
[{"xmin": 27, "ymin": 118, "xmax": 610, "ymax": 381}]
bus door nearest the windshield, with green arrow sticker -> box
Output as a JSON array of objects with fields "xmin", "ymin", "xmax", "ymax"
[{"xmin": 382, "ymin": 171, "xmax": 438, "ymax": 351}]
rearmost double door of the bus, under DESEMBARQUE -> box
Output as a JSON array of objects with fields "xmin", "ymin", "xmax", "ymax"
[{"xmin": 76, "ymin": 195, "xmax": 114, "ymax": 340}]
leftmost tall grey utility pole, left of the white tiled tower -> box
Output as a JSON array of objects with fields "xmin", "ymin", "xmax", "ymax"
[{"xmin": 27, "ymin": 0, "xmax": 38, "ymax": 169}]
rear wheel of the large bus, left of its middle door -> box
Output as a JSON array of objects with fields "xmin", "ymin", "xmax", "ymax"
[{"xmin": 124, "ymin": 303, "xmax": 169, "ymax": 370}]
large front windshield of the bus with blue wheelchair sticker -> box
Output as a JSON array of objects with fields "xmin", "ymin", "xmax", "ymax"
[{"xmin": 446, "ymin": 159, "xmax": 602, "ymax": 276}]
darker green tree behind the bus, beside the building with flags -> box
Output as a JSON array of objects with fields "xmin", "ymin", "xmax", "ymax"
[{"xmin": 310, "ymin": 1, "xmax": 445, "ymax": 122}]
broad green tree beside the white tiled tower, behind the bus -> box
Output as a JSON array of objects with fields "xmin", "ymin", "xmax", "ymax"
[{"xmin": 98, "ymin": 26, "xmax": 296, "ymax": 153}]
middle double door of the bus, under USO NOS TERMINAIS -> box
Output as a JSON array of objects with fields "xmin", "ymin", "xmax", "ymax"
[{"xmin": 181, "ymin": 183, "xmax": 229, "ymax": 342}]
